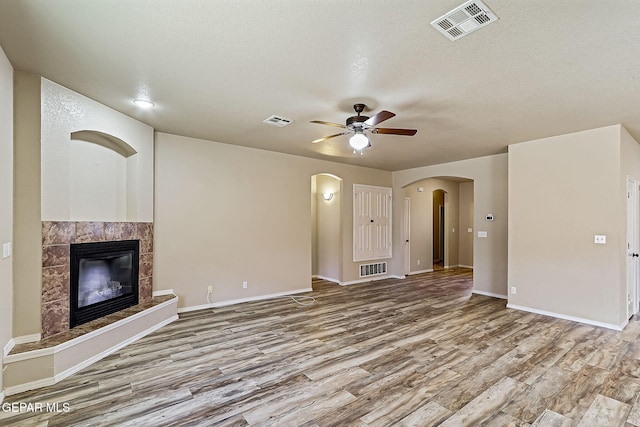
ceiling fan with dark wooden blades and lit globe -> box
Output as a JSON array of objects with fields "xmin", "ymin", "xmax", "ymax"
[{"xmin": 311, "ymin": 104, "xmax": 418, "ymax": 153}]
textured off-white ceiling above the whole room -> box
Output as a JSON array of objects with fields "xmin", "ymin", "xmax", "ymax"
[{"xmin": 0, "ymin": 0, "xmax": 640, "ymax": 170}]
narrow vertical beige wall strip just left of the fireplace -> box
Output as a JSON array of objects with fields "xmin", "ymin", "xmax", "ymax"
[{"xmin": 13, "ymin": 72, "xmax": 42, "ymax": 337}]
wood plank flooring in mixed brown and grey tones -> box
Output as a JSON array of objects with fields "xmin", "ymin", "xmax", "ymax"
[{"xmin": 0, "ymin": 268, "xmax": 640, "ymax": 427}]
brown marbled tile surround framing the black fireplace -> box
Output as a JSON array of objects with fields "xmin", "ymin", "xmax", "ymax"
[{"xmin": 41, "ymin": 221, "xmax": 153, "ymax": 338}]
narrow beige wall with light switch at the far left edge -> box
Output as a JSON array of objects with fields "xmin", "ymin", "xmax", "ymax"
[{"xmin": 0, "ymin": 48, "xmax": 13, "ymax": 400}]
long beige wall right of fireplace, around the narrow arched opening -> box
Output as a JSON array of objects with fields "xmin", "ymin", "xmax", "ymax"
[{"xmin": 154, "ymin": 133, "xmax": 391, "ymax": 307}]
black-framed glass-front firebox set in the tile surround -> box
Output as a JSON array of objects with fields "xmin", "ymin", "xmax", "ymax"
[{"xmin": 69, "ymin": 240, "xmax": 140, "ymax": 328}]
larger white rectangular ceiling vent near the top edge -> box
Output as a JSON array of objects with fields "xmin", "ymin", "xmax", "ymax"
[{"xmin": 431, "ymin": 0, "xmax": 498, "ymax": 41}]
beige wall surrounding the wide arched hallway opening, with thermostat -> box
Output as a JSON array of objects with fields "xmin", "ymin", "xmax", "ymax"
[{"xmin": 393, "ymin": 154, "xmax": 508, "ymax": 296}]
